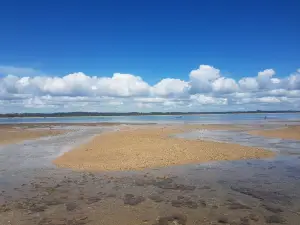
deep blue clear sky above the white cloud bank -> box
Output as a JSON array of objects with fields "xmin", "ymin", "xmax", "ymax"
[{"xmin": 0, "ymin": 0, "xmax": 300, "ymax": 110}]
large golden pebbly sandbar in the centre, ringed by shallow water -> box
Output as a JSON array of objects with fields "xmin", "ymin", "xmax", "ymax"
[{"xmin": 54, "ymin": 126, "xmax": 274, "ymax": 171}]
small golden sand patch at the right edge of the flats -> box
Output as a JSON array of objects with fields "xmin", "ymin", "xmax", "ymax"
[{"xmin": 249, "ymin": 125, "xmax": 300, "ymax": 140}]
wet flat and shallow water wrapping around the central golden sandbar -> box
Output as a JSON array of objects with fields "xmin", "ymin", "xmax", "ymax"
[{"xmin": 0, "ymin": 126, "xmax": 300, "ymax": 225}]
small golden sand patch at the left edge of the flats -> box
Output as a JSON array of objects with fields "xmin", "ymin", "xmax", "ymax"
[{"xmin": 0, "ymin": 125, "xmax": 65, "ymax": 145}]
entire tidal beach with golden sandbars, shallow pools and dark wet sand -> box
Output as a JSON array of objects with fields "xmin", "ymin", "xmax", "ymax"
[{"xmin": 0, "ymin": 118, "xmax": 300, "ymax": 225}]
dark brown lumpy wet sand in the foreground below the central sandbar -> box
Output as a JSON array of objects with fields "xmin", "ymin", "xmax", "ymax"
[{"xmin": 0, "ymin": 159, "xmax": 299, "ymax": 225}]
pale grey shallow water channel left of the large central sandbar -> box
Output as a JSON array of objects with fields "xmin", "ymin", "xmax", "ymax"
[{"xmin": 0, "ymin": 126, "xmax": 115, "ymax": 196}]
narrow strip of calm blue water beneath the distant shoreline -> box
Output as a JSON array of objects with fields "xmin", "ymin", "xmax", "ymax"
[{"xmin": 0, "ymin": 113, "xmax": 300, "ymax": 124}]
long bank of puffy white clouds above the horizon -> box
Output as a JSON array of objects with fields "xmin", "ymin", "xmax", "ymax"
[{"xmin": 0, "ymin": 65, "xmax": 300, "ymax": 113}]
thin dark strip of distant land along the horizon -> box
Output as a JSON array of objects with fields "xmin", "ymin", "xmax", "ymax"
[{"xmin": 0, "ymin": 110, "xmax": 300, "ymax": 118}]
